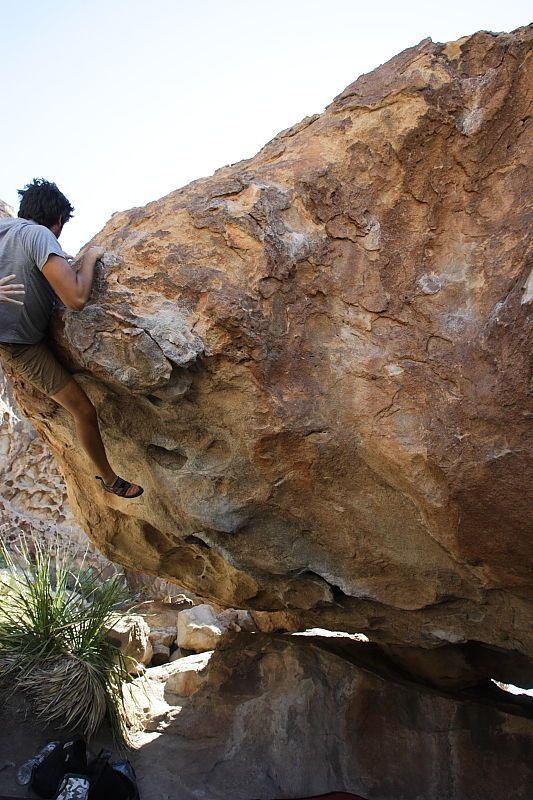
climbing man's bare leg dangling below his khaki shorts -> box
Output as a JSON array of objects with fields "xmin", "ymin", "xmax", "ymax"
[{"xmin": 52, "ymin": 378, "xmax": 139, "ymax": 497}]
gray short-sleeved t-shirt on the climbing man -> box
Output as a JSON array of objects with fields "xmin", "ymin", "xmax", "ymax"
[{"xmin": 0, "ymin": 217, "xmax": 65, "ymax": 344}]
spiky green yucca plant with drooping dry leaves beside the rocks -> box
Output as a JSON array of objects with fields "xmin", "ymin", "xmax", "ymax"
[{"xmin": 0, "ymin": 539, "xmax": 137, "ymax": 743}]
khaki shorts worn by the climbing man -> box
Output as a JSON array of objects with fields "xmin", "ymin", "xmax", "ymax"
[{"xmin": 0, "ymin": 340, "xmax": 72, "ymax": 396}]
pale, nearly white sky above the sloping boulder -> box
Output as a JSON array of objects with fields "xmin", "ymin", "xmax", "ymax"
[{"xmin": 0, "ymin": 0, "xmax": 531, "ymax": 254}]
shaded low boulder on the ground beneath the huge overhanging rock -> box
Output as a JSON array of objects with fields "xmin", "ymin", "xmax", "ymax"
[{"xmin": 129, "ymin": 633, "xmax": 533, "ymax": 800}]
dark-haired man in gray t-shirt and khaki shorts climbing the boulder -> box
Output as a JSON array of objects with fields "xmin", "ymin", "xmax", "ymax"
[{"xmin": 0, "ymin": 178, "xmax": 143, "ymax": 499}]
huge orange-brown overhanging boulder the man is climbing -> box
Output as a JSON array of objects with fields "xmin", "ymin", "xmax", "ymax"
[{"xmin": 11, "ymin": 28, "xmax": 533, "ymax": 680}]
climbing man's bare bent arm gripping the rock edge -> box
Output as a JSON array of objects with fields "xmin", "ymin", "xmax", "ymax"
[{"xmin": 42, "ymin": 247, "xmax": 104, "ymax": 311}]
